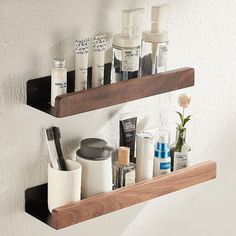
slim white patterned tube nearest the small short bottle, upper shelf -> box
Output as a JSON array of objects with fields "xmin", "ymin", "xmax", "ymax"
[{"xmin": 75, "ymin": 38, "xmax": 89, "ymax": 91}]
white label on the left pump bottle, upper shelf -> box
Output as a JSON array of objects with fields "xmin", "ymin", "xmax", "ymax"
[{"xmin": 122, "ymin": 48, "xmax": 139, "ymax": 72}]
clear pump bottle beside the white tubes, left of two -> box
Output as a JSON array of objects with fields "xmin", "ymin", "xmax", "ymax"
[{"xmin": 111, "ymin": 8, "xmax": 144, "ymax": 83}]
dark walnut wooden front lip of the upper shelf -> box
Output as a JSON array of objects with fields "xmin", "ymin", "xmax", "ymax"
[{"xmin": 55, "ymin": 67, "xmax": 194, "ymax": 118}]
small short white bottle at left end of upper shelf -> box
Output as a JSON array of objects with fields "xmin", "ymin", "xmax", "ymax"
[{"xmin": 51, "ymin": 58, "xmax": 67, "ymax": 107}]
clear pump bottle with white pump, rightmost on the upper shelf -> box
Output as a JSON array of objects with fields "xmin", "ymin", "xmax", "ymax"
[{"xmin": 140, "ymin": 5, "xmax": 168, "ymax": 76}]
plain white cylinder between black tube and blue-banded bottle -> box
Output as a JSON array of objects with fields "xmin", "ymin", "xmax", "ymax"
[{"xmin": 136, "ymin": 132, "xmax": 155, "ymax": 182}]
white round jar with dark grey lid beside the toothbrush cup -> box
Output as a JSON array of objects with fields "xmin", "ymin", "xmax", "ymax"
[{"xmin": 76, "ymin": 138, "xmax": 113, "ymax": 198}]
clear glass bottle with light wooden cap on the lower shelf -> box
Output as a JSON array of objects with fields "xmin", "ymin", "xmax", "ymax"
[{"xmin": 113, "ymin": 147, "xmax": 135, "ymax": 189}]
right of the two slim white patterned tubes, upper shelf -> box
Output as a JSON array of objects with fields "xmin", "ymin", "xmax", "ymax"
[{"xmin": 92, "ymin": 35, "xmax": 106, "ymax": 88}]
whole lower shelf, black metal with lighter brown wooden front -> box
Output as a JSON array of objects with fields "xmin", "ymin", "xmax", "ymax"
[{"xmin": 25, "ymin": 161, "xmax": 216, "ymax": 229}]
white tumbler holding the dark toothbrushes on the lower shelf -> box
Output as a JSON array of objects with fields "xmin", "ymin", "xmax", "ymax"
[{"xmin": 48, "ymin": 160, "xmax": 82, "ymax": 212}]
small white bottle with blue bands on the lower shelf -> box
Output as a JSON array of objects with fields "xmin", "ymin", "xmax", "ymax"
[{"xmin": 153, "ymin": 130, "xmax": 171, "ymax": 176}]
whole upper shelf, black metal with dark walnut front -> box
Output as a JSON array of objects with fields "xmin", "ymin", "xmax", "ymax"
[{"xmin": 27, "ymin": 64, "xmax": 194, "ymax": 117}]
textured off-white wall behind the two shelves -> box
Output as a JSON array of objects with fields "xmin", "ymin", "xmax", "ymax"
[{"xmin": 0, "ymin": 0, "xmax": 236, "ymax": 236}]
